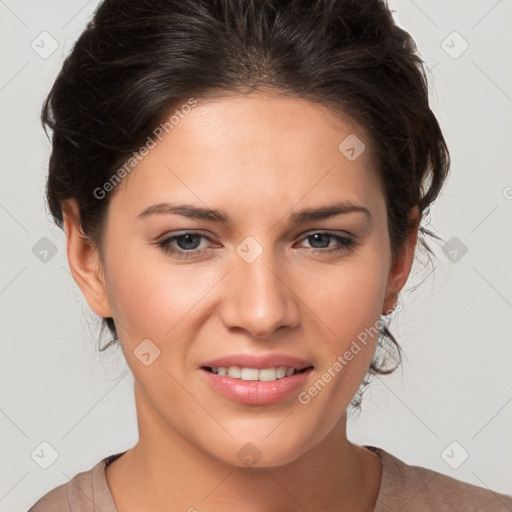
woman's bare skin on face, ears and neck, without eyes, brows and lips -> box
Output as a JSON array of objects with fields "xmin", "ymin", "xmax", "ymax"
[{"xmin": 65, "ymin": 93, "xmax": 418, "ymax": 512}]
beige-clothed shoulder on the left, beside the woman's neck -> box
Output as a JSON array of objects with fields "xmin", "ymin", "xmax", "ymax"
[{"xmin": 28, "ymin": 454, "xmax": 121, "ymax": 512}]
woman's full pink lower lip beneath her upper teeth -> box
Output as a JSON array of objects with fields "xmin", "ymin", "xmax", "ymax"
[{"xmin": 200, "ymin": 367, "xmax": 313, "ymax": 405}]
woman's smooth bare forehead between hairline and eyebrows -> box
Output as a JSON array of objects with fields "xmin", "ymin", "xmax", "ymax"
[{"xmin": 112, "ymin": 94, "xmax": 380, "ymax": 214}]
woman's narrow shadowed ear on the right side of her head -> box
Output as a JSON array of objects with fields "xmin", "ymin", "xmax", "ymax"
[{"xmin": 382, "ymin": 206, "xmax": 420, "ymax": 315}]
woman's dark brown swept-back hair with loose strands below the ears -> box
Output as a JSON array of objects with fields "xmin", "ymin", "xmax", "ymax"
[{"xmin": 41, "ymin": 0, "xmax": 449, "ymax": 409}]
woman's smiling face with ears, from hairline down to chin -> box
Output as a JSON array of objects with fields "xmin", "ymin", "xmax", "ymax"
[{"xmin": 67, "ymin": 95, "xmax": 415, "ymax": 466}]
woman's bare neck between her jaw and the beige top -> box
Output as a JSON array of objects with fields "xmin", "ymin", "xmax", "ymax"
[{"xmin": 106, "ymin": 387, "xmax": 381, "ymax": 512}]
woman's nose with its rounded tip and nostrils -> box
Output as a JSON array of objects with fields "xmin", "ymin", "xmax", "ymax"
[{"xmin": 221, "ymin": 251, "xmax": 300, "ymax": 339}]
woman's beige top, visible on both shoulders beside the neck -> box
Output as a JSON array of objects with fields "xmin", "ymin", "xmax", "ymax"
[{"xmin": 28, "ymin": 445, "xmax": 512, "ymax": 512}]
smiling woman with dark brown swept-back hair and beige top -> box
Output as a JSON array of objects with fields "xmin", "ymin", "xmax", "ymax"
[{"xmin": 30, "ymin": 0, "xmax": 512, "ymax": 512}]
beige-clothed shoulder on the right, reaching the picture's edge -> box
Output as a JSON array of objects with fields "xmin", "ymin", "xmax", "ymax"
[{"xmin": 370, "ymin": 447, "xmax": 512, "ymax": 512}]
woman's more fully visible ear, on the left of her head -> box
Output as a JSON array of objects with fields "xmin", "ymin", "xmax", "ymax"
[{"xmin": 62, "ymin": 199, "xmax": 113, "ymax": 318}]
